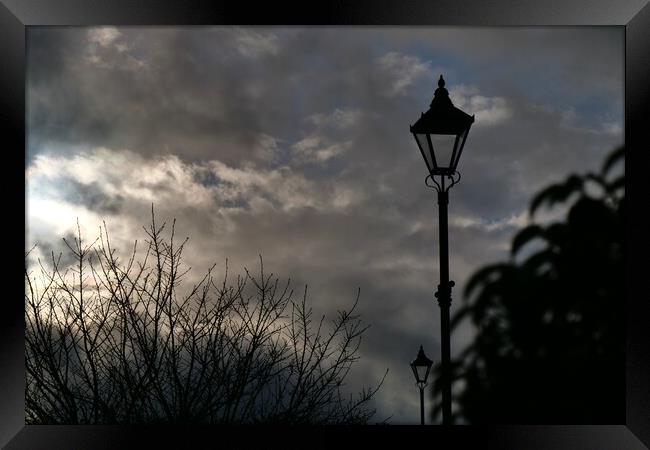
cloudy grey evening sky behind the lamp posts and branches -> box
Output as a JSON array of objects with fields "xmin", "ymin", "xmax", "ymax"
[{"xmin": 25, "ymin": 26, "xmax": 624, "ymax": 424}]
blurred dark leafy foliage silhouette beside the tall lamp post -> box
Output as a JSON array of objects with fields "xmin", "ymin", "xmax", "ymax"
[{"xmin": 432, "ymin": 147, "xmax": 625, "ymax": 424}]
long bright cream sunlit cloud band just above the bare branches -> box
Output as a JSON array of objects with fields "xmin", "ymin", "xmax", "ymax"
[{"xmin": 26, "ymin": 148, "xmax": 361, "ymax": 230}]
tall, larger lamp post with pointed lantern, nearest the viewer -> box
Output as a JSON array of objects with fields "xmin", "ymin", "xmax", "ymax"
[{"xmin": 410, "ymin": 75, "xmax": 474, "ymax": 425}]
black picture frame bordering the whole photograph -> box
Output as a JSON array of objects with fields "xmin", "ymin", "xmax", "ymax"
[{"xmin": 5, "ymin": 0, "xmax": 650, "ymax": 450}]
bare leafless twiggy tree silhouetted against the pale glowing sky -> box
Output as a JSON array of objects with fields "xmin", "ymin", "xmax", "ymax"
[{"xmin": 25, "ymin": 207, "xmax": 386, "ymax": 424}]
